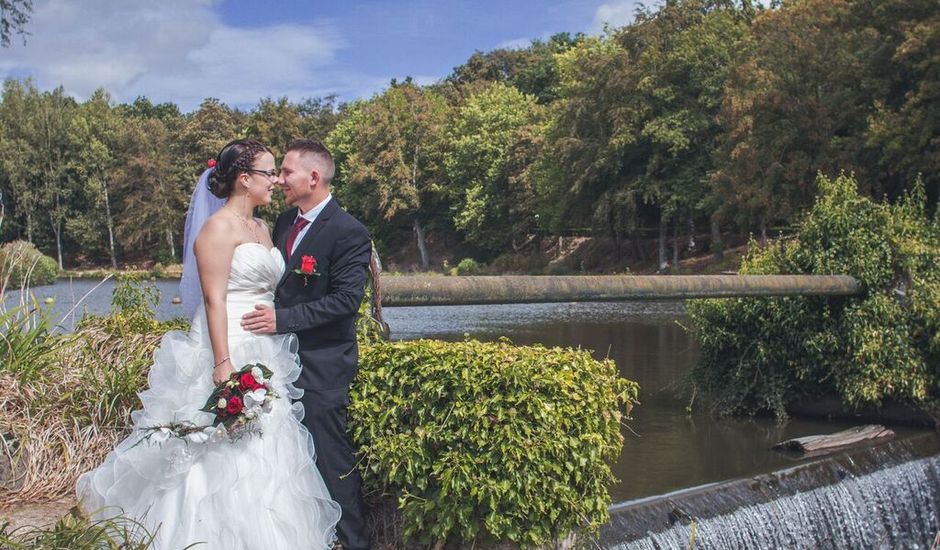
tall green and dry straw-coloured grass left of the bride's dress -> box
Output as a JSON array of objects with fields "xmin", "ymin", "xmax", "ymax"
[{"xmin": 0, "ymin": 279, "xmax": 185, "ymax": 504}]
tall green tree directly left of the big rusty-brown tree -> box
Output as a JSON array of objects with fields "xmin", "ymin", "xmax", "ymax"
[{"xmin": 617, "ymin": 0, "xmax": 753, "ymax": 266}]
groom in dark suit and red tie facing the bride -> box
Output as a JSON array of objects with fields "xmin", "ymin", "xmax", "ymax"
[{"xmin": 242, "ymin": 139, "xmax": 372, "ymax": 550}]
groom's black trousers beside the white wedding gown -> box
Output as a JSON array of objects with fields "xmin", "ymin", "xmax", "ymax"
[{"xmin": 300, "ymin": 388, "xmax": 369, "ymax": 550}]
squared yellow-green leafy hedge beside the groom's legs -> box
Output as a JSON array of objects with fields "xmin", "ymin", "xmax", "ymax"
[{"xmin": 350, "ymin": 340, "xmax": 637, "ymax": 546}]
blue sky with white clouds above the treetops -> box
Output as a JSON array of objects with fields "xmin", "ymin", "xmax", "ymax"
[{"xmin": 0, "ymin": 0, "xmax": 639, "ymax": 112}]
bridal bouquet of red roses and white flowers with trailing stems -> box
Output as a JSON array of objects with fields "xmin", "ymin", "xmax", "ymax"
[{"xmin": 135, "ymin": 363, "xmax": 278, "ymax": 443}]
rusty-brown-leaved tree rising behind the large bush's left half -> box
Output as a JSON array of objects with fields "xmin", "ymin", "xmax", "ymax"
[{"xmin": 712, "ymin": 0, "xmax": 887, "ymax": 235}]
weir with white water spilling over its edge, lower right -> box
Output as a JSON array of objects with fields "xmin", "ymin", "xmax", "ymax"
[{"xmin": 598, "ymin": 434, "xmax": 940, "ymax": 550}]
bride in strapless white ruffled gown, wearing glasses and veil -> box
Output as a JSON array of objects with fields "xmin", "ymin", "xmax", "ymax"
[{"xmin": 77, "ymin": 140, "xmax": 340, "ymax": 550}]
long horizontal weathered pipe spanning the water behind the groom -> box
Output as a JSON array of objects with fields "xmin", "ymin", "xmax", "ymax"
[{"xmin": 380, "ymin": 275, "xmax": 860, "ymax": 306}]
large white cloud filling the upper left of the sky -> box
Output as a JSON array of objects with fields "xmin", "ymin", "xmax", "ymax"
[{"xmin": 0, "ymin": 0, "xmax": 352, "ymax": 111}]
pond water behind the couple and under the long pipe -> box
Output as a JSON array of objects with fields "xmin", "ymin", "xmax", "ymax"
[{"xmin": 4, "ymin": 280, "xmax": 924, "ymax": 502}]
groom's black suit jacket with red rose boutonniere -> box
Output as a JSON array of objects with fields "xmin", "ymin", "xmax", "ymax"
[{"xmin": 273, "ymin": 198, "xmax": 372, "ymax": 389}]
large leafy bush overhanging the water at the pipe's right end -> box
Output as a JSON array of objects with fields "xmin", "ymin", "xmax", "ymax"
[{"xmin": 688, "ymin": 175, "xmax": 940, "ymax": 417}]
